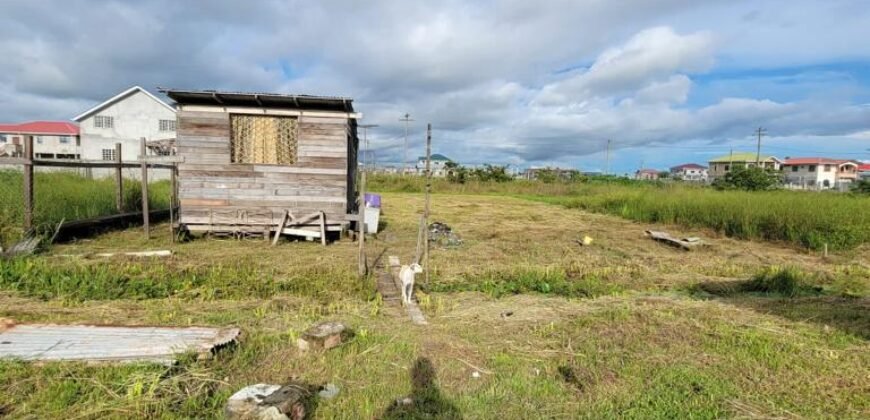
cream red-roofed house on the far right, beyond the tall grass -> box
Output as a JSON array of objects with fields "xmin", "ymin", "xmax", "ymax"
[{"xmin": 782, "ymin": 157, "xmax": 858, "ymax": 190}]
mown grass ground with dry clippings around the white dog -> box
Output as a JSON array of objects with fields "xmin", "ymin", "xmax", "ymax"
[{"xmin": 0, "ymin": 192, "xmax": 870, "ymax": 419}]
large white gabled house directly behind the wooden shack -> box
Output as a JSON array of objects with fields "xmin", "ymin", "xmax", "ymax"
[{"xmin": 73, "ymin": 86, "xmax": 176, "ymax": 166}]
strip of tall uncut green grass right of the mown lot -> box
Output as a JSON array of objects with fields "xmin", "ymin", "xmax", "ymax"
[{"xmin": 371, "ymin": 176, "xmax": 870, "ymax": 250}]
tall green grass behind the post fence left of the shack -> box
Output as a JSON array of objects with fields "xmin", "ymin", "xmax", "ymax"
[{"xmin": 0, "ymin": 170, "xmax": 169, "ymax": 243}]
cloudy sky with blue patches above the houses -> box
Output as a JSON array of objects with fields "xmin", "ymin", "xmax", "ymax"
[{"xmin": 0, "ymin": 0, "xmax": 870, "ymax": 173}]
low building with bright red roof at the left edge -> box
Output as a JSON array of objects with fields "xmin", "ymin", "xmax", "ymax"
[{"xmin": 0, "ymin": 121, "xmax": 81, "ymax": 159}]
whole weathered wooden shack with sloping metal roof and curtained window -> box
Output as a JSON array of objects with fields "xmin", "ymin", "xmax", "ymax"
[{"xmin": 163, "ymin": 90, "xmax": 361, "ymax": 237}]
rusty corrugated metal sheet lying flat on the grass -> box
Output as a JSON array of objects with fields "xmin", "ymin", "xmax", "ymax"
[{"xmin": 0, "ymin": 324, "xmax": 239, "ymax": 364}]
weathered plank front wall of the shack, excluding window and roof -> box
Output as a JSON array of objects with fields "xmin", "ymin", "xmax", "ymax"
[{"xmin": 176, "ymin": 108, "xmax": 357, "ymax": 224}]
